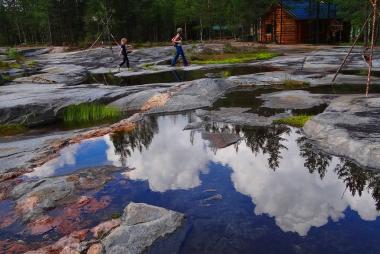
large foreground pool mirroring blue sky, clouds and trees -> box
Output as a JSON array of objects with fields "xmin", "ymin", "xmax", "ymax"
[{"xmin": 23, "ymin": 114, "xmax": 380, "ymax": 253}]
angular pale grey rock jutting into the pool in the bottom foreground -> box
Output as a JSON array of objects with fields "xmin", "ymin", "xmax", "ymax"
[{"xmin": 102, "ymin": 203, "xmax": 184, "ymax": 254}]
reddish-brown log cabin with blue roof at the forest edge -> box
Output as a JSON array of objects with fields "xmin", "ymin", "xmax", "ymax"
[{"xmin": 259, "ymin": 0, "xmax": 351, "ymax": 44}]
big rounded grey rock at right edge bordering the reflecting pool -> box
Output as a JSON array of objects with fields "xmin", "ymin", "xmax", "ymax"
[{"xmin": 304, "ymin": 95, "xmax": 380, "ymax": 169}]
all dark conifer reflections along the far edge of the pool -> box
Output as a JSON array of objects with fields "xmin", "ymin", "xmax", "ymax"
[{"xmin": 111, "ymin": 114, "xmax": 380, "ymax": 210}]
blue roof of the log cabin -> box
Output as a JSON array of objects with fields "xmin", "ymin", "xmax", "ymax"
[{"xmin": 279, "ymin": 0, "xmax": 337, "ymax": 20}]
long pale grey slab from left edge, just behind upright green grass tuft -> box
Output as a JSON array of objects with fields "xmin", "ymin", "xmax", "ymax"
[{"xmin": 0, "ymin": 84, "xmax": 138, "ymax": 126}]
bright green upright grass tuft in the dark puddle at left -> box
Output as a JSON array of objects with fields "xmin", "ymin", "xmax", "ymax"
[{"xmin": 63, "ymin": 103, "xmax": 121, "ymax": 124}]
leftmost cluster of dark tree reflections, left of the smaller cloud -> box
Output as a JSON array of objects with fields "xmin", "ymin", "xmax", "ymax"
[{"xmin": 111, "ymin": 117, "xmax": 159, "ymax": 166}]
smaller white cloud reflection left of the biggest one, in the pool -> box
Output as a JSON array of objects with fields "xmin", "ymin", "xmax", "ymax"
[{"xmin": 106, "ymin": 116, "xmax": 209, "ymax": 192}]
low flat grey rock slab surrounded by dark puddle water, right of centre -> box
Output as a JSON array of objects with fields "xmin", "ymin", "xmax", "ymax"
[{"xmin": 258, "ymin": 90, "xmax": 335, "ymax": 109}]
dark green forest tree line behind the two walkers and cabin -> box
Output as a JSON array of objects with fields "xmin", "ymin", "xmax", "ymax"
[{"xmin": 0, "ymin": 0, "xmax": 370, "ymax": 45}]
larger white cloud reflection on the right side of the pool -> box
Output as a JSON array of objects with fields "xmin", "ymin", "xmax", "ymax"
[{"xmin": 216, "ymin": 133, "xmax": 379, "ymax": 236}]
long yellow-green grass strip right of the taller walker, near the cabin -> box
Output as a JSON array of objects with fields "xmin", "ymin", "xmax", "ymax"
[{"xmin": 190, "ymin": 51, "xmax": 280, "ymax": 64}]
